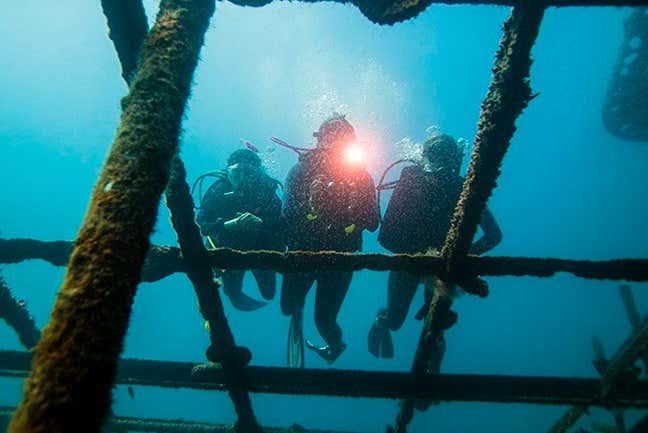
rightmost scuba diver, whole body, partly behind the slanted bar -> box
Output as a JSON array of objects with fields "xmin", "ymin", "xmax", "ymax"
[{"xmin": 368, "ymin": 134, "xmax": 502, "ymax": 362}]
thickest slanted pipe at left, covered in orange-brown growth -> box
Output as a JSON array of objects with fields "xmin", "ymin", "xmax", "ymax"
[{"xmin": 9, "ymin": 0, "xmax": 214, "ymax": 433}]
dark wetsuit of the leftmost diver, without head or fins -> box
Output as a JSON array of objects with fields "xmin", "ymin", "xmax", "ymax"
[{"xmin": 196, "ymin": 174, "xmax": 284, "ymax": 300}]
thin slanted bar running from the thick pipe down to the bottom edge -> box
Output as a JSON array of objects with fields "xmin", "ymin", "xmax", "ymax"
[{"xmin": 166, "ymin": 157, "xmax": 262, "ymax": 433}]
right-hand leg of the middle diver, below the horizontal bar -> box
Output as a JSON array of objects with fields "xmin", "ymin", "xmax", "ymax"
[{"xmin": 311, "ymin": 272, "xmax": 353, "ymax": 363}]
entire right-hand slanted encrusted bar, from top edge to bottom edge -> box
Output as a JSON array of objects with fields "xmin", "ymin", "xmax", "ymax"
[{"xmin": 390, "ymin": 0, "xmax": 545, "ymax": 433}]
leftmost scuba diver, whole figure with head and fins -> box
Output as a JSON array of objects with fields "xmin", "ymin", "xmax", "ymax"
[{"xmin": 194, "ymin": 148, "xmax": 284, "ymax": 311}]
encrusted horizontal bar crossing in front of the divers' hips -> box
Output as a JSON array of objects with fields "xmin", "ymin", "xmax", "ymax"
[{"xmin": 0, "ymin": 239, "xmax": 648, "ymax": 282}]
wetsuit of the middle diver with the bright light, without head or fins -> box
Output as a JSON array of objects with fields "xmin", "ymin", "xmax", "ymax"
[{"xmin": 281, "ymin": 152, "xmax": 379, "ymax": 348}]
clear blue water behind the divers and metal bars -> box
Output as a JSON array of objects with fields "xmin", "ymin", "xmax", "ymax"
[{"xmin": 0, "ymin": 0, "xmax": 648, "ymax": 433}]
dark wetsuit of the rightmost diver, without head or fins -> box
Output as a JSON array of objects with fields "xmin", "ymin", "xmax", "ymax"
[{"xmin": 378, "ymin": 165, "xmax": 502, "ymax": 331}]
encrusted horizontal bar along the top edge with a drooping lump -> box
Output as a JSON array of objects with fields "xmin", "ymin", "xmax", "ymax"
[{"xmin": 230, "ymin": 0, "xmax": 648, "ymax": 24}]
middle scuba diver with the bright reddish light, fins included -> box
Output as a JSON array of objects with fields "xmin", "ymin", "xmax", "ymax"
[{"xmin": 274, "ymin": 115, "xmax": 380, "ymax": 367}]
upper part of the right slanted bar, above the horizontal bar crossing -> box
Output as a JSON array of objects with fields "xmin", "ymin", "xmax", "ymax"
[{"xmin": 441, "ymin": 0, "xmax": 544, "ymax": 279}]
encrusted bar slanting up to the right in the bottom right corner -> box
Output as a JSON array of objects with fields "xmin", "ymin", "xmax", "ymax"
[{"xmin": 549, "ymin": 317, "xmax": 648, "ymax": 433}]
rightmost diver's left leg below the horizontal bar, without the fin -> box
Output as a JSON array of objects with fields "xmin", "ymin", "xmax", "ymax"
[{"xmin": 385, "ymin": 271, "xmax": 421, "ymax": 331}]
